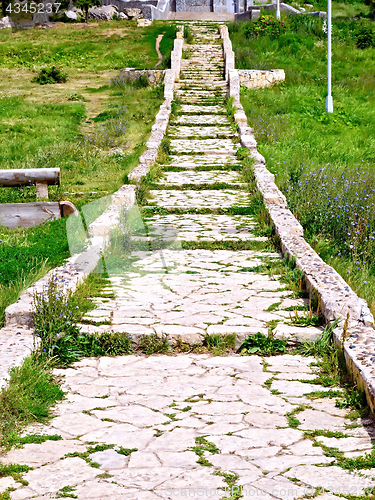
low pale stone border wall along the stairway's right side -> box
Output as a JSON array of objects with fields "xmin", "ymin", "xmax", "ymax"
[{"xmin": 220, "ymin": 26, "xmax": 375, "ymax": 411}]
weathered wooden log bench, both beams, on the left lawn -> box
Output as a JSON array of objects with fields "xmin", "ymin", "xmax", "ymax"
[{"xmin": 0, "ymin": 168, "xmax": 78, "ymax": 228}]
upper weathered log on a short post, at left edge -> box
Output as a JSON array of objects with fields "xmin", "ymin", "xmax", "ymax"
[{"xmin": 0, "ymin": 168, "xmax": 60, "ymax": 200}]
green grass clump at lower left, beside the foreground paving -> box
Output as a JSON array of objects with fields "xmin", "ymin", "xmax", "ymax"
[{"xmin": 0, "ymin": 357, "xmax": 64, "ymax": 450}]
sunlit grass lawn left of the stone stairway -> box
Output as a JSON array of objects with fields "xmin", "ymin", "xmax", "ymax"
[{"xmin": 0, "ymin": 21, "xmax": 175, "ymax": 323}]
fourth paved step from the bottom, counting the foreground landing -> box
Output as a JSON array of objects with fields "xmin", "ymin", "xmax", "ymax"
[{"xmin": 148, "ymin": 189, "xmax": 249, "ymax": 210}]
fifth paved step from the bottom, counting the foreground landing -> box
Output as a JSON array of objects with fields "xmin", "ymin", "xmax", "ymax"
[{"xmin": 157, "ymin": 170, "xmax": 242, "ymax": 187}]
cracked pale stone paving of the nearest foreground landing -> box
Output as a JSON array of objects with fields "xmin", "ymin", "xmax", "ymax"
[{"xmin": 0, "ymin": 354, "xmax": 375, "ymax": 500}]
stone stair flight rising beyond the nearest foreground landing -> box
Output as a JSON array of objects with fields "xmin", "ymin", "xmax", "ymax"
[{"xmin": 82, "ymin": 23, "xmax": 322, "ymax": 346}]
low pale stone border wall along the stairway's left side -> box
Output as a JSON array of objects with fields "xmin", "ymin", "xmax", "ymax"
[{"xmin": 0, "ymin": 28, "xmax": 183, "ymax": 387}]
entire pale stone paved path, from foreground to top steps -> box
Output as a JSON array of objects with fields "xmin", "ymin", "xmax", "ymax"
[{"xmin": 0, "ymin": 20, "xmax": 375, "ymax": 500}]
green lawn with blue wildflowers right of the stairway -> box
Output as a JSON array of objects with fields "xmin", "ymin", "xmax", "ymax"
[{"xmin": 230, "ymin": 4, "xmax": 375, "ymax": 312}]
